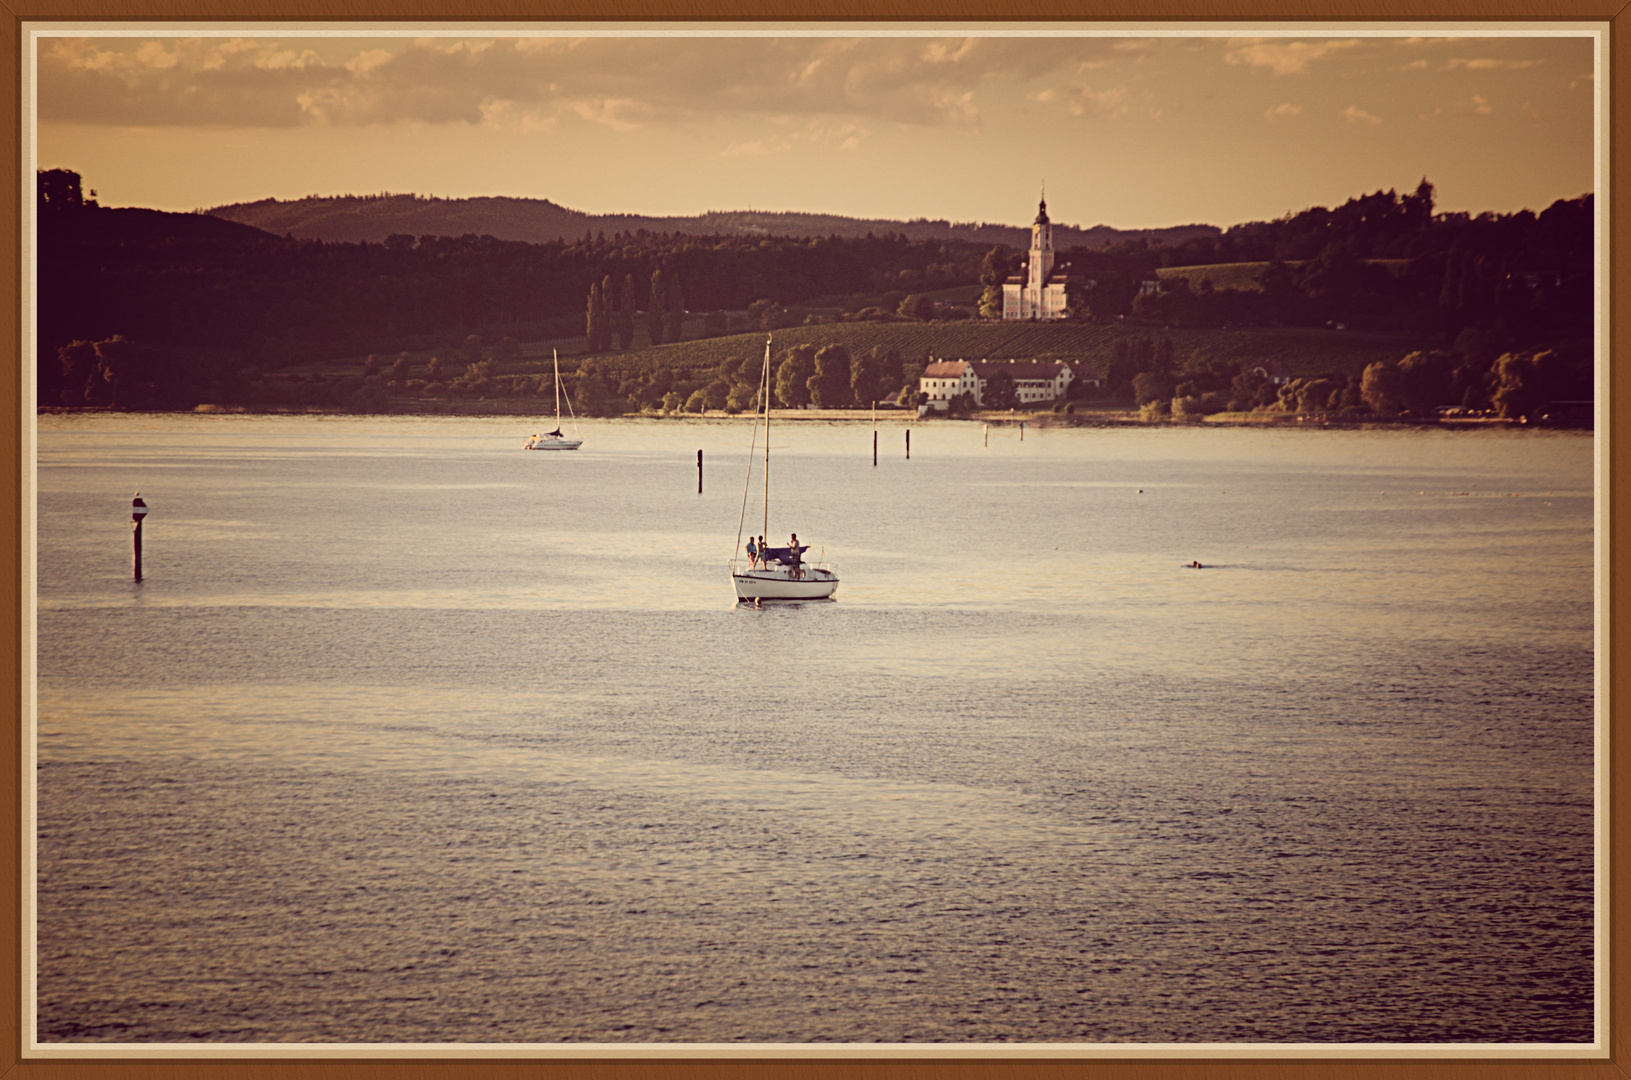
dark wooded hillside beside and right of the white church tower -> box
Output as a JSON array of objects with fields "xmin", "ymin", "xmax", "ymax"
[{"xmin": 1030, "ymin": 178, "xmax": 1595, "ymax": 344}]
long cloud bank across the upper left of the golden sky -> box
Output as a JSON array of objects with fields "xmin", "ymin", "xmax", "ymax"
[{"xmin": 39, "ymin": 38, "xmax": 1138, "ymax": 131}]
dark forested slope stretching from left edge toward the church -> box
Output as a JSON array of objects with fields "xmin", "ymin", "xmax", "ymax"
[{"xmin": 36, "ymin": 170, "xmax": 983, "ymax": 405}]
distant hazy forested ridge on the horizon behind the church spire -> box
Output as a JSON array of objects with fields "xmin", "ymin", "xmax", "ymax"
[{"xmin": 206, "ymin": 194, "xmax": 1220, "ymax": 250}]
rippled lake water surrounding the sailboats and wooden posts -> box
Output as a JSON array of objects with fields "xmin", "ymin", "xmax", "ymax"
[{"xmin": 36, "ymin": 416, "xmax": 1595, "ymax": 1046}]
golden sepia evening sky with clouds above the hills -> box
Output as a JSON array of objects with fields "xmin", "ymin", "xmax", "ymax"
[{"xmin": 24, "ymin": 24, "xmax": 1598, "ymax": 228}]
